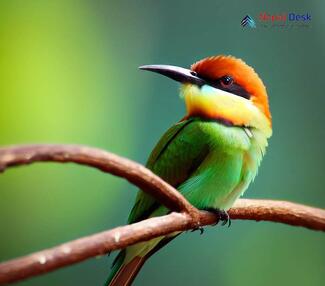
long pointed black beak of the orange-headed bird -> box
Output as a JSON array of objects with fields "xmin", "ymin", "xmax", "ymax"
[{"xmin": 139, "ymin": 65, "xmax": 206, "ymax": 86}]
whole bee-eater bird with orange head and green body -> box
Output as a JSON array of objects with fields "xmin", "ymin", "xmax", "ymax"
[{"xmin": 105, "ymin": 55, "xmax": 272, "ymax": 286}]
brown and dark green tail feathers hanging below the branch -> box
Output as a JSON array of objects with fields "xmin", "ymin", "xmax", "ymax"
[{"xmin": 105, "ymin": 250, "xmax": 147, "ymax": 286}]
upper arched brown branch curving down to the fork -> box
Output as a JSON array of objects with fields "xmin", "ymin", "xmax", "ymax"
[{"xmin": 0, "ymin": 144, "xmax": 198, "ymax": 218}]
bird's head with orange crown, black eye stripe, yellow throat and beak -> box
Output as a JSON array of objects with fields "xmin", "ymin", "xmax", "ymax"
[{"xmin": 140, "ymin": 56, "xmax": 272, "ymax": 137}]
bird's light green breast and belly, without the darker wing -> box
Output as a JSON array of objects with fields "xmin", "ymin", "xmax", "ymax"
[{"xmin": 184, "ymin": 125, "xmax": 265, "ymax": 209}]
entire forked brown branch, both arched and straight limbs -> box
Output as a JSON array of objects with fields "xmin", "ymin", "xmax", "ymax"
[{"xmin": 0, "ymin": 145, "xmax": 325, "ymax": 284}]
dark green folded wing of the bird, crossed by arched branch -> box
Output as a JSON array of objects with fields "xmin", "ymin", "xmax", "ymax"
[{"xmin": 128, "ymin": 119, "xmax": 209, "ymax": 223}]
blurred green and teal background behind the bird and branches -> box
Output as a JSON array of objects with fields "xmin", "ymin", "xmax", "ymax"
[{"xmin": 0, "ymin": 0, "xmax": 325, "ymax": 286}]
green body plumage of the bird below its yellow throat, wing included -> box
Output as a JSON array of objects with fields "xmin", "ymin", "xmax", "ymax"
[{"xmin": 105, "ymin": 118, "xmax": 267, "ymax": 284}]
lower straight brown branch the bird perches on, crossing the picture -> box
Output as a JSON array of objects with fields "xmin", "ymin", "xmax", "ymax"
[{"xmin": 0, "ymin": 200, "xmax": 325, "ymax": 284}]
